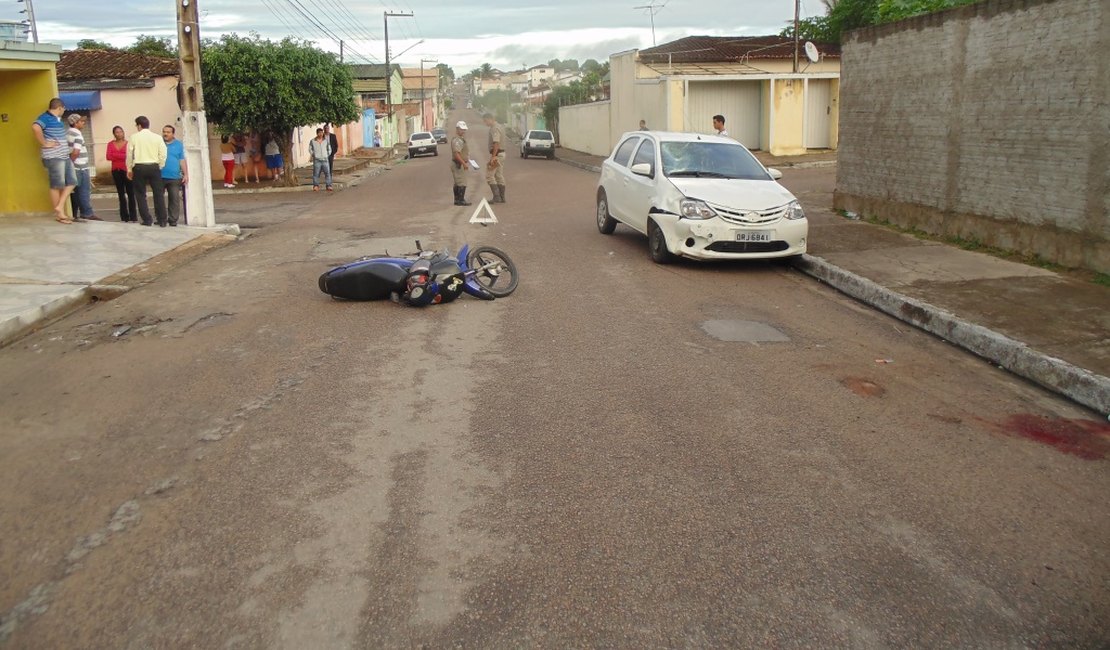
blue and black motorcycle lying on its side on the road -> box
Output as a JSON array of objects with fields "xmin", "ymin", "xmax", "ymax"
[{"xmin": 320, "ymin": 241, "xmax": 519, "ymax": 306}]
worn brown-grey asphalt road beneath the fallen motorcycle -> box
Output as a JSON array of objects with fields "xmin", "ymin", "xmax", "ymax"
[{"xmin": 0, "ymin": 112, "xmax": 1110, "ymax": 648}]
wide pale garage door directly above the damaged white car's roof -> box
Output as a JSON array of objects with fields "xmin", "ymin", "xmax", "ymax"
[{"xmin": 686, "ymin": 81, "xmax": 763, "ymax": 149}]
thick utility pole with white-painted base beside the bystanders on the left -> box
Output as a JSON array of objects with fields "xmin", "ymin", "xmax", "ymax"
[{"xmin": 176, "ymin": 0, "xmax": 215, "ymax": 227}]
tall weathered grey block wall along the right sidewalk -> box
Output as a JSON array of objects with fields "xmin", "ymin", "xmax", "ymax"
[{"xmin": 836, "ymin": 0, "xmax": 1110, "ymax": 272}]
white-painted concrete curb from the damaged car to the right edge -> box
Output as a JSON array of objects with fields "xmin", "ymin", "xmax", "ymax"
[{"xmin": 794, "ymin": 250, "xmax": 1110, "ymax": 415}]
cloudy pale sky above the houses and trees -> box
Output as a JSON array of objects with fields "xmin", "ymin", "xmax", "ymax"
[{"xmin": 8, "ymin": 0, "xmax": 824, "ymax": 75}]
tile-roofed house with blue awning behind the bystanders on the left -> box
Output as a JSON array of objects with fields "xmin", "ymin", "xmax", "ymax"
[{"xmin": 58, "ymin": 50, "xmax": 181, "ymax": 174}]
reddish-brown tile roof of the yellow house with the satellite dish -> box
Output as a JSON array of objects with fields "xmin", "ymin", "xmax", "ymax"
[{"xmin": 639, "ymin": 37, "xmax": 840, "ymax": 63}]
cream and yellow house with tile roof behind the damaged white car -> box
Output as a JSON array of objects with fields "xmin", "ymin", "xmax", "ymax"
[{"xmin": 558, "ymin": 35, "xmax": 840, "ymax": 155}]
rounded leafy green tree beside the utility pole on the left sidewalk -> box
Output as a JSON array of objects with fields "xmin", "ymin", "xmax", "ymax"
[{"xmin": 201, "ymin": 34, "xmax": 359, "ymax": 185}]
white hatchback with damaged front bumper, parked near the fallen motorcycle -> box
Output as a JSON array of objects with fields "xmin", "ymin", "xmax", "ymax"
[{"xmin": 597, "ymin": 131, "xmax": 809, "ymax": 264}]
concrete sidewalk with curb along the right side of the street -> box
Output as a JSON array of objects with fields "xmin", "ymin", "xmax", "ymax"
[{"xmin": 556, "ymin": 149, "xmax": 1110, "ymax": 415}]
